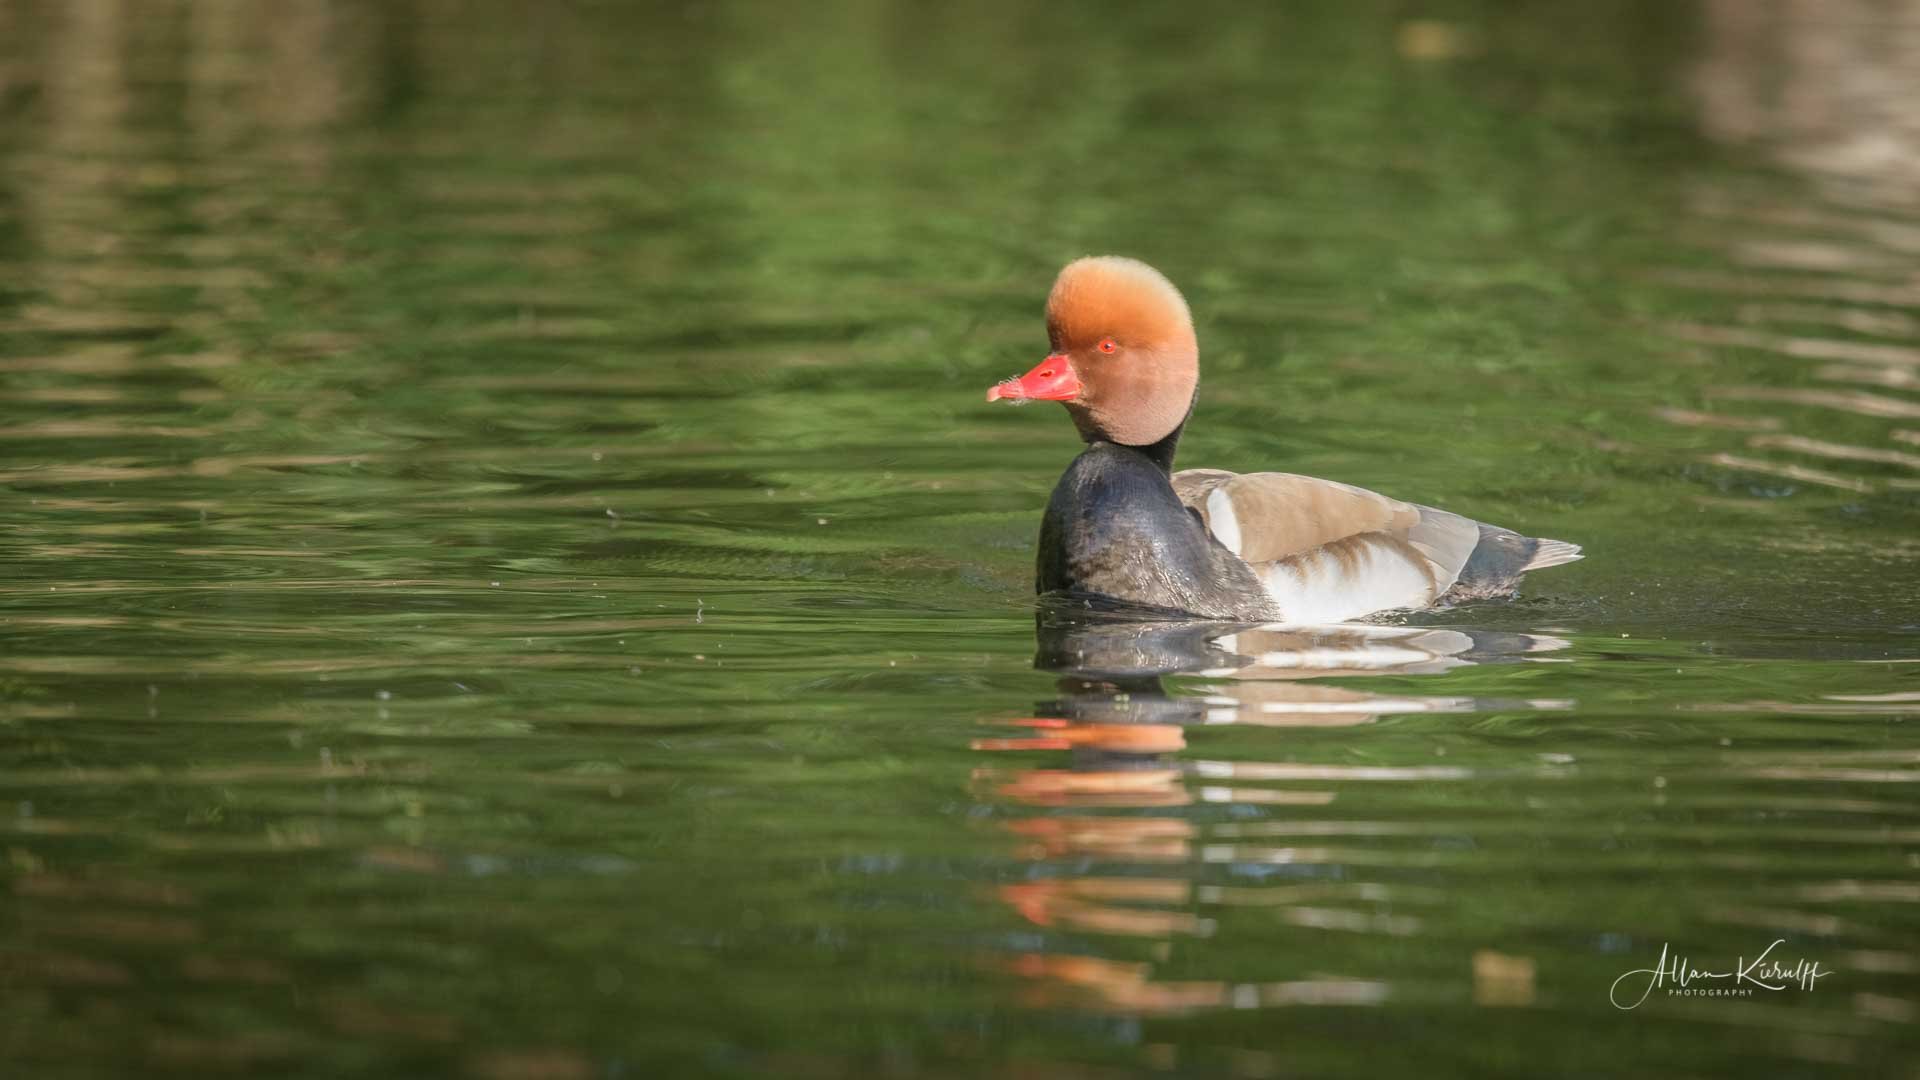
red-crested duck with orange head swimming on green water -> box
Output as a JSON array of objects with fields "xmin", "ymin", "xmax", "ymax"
[{"xmin": 987, "ymin": 256, "xmax": 1582, "ymax": 625}]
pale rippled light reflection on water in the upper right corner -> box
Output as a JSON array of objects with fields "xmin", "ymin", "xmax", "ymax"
[{"xmin": 1661, "ymin": 2, "xmax": 1920, "ymax": 494}]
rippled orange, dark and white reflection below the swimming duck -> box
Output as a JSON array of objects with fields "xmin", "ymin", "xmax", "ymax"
[{"xmin": 973, "ymin": 609, "xmax": 1567, "ymax": 1015}]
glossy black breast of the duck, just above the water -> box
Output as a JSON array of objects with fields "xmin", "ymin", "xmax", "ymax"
[{"xmin": 1035, "ymin": 442, "xmax": 1279, "ymax": 621}]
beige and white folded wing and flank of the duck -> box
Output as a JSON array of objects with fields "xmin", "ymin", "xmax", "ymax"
[{"xmin": 1173, "ymin": 469, "xmax": 1480, "ymax": 623}]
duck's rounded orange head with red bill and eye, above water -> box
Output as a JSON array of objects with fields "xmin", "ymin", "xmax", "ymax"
[{"xmin": 987, "ymin": 256, "xmax": 1200, "ymax": 446}]
